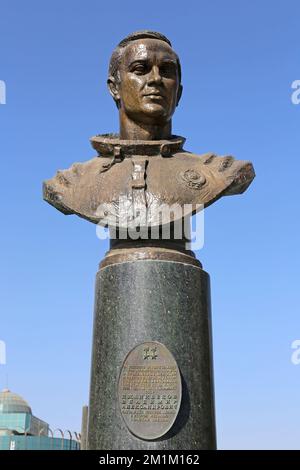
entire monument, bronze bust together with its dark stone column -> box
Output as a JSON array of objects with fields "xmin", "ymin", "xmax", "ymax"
[{"xmin": 44, "ymin": 31, "xmax": 255, "ymax": 451}]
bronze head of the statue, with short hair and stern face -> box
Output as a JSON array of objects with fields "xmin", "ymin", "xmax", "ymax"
[{"xmin": 107, "ymin": 31, "xmax": 182, "ymax": 125}]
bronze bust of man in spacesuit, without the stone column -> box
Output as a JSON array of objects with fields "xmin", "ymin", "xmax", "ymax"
[{"xmin": 44, "ymin": 31, "xmax": 255, "ymax": 226}]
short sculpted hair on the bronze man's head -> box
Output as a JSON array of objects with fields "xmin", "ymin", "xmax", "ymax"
[{"xmin": 108, "ymin": 30, "xmax": 181, "ymax": 83}]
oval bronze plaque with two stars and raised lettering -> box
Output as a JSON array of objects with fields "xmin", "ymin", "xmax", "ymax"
[{"xmin": 118, "ymin": 341, "xmax": 182, "ymax": 440}]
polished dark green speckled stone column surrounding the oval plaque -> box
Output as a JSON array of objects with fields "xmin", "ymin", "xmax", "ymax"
[{"xmin": 88, "ymin": 260, "xmax": 216, "ymax": 450}]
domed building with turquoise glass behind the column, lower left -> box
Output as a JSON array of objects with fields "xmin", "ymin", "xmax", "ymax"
[{"xmin": 0, "ymin": 389, "xmax": 80, "ymax": 450}]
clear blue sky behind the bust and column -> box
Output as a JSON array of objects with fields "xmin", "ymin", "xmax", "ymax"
[{"xmin": 0, "ymin": 0, "xmax": 300, "ymax": 449}]
